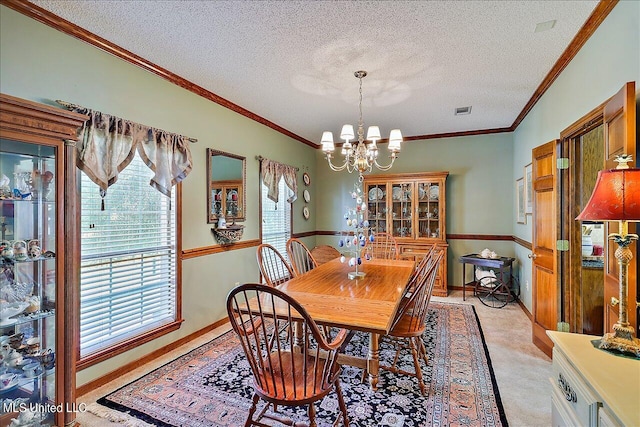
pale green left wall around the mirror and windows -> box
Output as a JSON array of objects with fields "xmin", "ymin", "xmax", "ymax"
[{"xmin": 0, "ymin": 6, "xmax": 315, "ymax": 385}]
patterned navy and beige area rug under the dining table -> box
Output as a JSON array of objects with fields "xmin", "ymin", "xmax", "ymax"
[{"xmin": 98, "ymin": 302, "xmax": 507, "ymax": 427}]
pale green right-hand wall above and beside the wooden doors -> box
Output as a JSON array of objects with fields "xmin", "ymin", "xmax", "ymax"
[{"xmin": 512, "ymin": 1, "xmax": 640, "ymax": 311}]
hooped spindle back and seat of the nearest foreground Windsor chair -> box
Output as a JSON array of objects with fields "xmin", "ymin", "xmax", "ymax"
[{"xmin": 227, "ymin": 283, "xmax": 347, "ymax": 406}]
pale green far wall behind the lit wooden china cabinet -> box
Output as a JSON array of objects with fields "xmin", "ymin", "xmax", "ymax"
[{"xmin": 316, "ymin": 133, "xmax": 514, "ymax": 294}]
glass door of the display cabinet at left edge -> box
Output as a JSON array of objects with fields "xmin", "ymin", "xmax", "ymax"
[{"xmin": 0, "ymin": 140, "xmax": 60, "ymax": 425}]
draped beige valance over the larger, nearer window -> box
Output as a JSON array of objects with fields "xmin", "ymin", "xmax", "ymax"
[{"xmin": 57, "ymin": 101, "xmax": 195, "ymax": 206}]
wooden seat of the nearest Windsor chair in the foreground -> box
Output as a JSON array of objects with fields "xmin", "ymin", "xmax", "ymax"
[{"xmin": 254, "ymin": 351, "xmax": 340, "ymax": 405}]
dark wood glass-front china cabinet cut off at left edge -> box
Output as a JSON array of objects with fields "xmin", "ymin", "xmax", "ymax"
[{"xmin": 0, "ymin": 94, "xmax": 86, "ymax": 427}]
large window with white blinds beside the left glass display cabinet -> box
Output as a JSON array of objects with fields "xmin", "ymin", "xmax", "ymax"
[{"xmin": 79, "ymin": 154, "xmax": 180, "ymax": 366}]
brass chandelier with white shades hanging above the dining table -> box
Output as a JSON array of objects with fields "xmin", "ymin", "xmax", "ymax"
[{"xmin": 321, "ymin": 71, "xmax": 402, "ymax": 179}]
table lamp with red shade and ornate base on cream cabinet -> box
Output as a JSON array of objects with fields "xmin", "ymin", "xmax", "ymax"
[{"xmin": 576, "ymin": 155, "xmax": 640, "ymax": 358}]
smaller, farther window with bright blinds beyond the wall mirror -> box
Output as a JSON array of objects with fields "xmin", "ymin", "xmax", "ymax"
[{"xmin": 260, "ymin": 179, "xmax": 291, "ymax": 259}]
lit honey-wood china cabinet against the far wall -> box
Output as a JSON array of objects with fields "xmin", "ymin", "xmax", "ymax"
[{"xmin": 364, "ymin": 172, "xmax": 449, "ymax": 296}]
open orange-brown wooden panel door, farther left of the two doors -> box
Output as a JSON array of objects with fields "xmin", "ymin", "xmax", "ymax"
[{"xmin": 529, "ymin": 140, "xmax": 560, "ymax": 356}]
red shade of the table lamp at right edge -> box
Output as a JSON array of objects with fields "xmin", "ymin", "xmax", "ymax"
[{"xmin": 576, "ymin": 168, "xmax": 640, "ymax": 221}]
